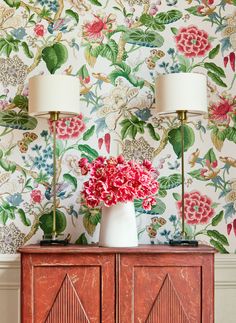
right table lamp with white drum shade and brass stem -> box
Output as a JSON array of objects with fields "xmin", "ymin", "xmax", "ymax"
[{"xmin": 156, "ymin": 73, "xmax": 207, "ymax": 246}]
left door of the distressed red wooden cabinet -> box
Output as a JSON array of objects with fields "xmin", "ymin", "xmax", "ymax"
[{"xmin": 22, "ymin": 254, "xmax": 115, "ymax": 323}]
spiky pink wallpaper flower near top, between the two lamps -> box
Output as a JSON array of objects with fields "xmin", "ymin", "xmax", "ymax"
[{"xmin": 83, "ymin": 15, "xmax": 114, "ymax": 42}]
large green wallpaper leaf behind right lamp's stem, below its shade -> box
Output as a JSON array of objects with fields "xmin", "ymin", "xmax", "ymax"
[{"xmin": 168, "ymin": 125, "xmax": 195, "ymax": 158}]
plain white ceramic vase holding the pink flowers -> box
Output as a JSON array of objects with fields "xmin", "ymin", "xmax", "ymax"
[{"xmin": 99, "ymin": 202, "xmax": 138, "ymax": 247}]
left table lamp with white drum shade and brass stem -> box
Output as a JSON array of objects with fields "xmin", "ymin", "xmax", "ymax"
[{"xmin": 28, "ymin": 75, "xmax": 80, "ymax": 245}]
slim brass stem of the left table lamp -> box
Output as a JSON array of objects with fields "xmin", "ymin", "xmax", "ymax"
[{"xmin": 50, "ymin": 112, "xmax": 59, "ymax": 240}]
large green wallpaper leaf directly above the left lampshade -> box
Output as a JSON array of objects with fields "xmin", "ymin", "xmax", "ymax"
[{"xmin": 42, "ymin": 43, "xmax": 68, "ymax": 74}]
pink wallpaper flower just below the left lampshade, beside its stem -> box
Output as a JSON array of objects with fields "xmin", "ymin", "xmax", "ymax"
[{"xmin": 49, "ymin": 114, "xmax": 85, "ymax": 139}]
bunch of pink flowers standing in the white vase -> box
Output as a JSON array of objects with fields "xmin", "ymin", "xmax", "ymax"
[{"xmin": 79, "ymin": 155, "xmax": 159, "ymax": 210}]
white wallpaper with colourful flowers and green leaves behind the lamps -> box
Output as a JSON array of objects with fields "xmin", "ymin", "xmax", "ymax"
[{"xmin": 0, "ymin": 0, "xmax": 236, "ymax": 253}]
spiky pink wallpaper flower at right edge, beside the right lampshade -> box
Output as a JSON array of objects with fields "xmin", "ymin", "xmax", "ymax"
[{"xmin": 209, "ymin": 97, "xmax": 234, "ymax": 124}]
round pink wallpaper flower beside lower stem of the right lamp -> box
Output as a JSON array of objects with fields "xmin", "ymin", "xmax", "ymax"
[{"xmin": 177, "ymin": 191, "xmax": 215, "ymax": 225}]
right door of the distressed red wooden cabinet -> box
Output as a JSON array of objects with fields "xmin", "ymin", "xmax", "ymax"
[{"xmin": 119, "ymin": 254, "xmax": 213, "ymax": 323}]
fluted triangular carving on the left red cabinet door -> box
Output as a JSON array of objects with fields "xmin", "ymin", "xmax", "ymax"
[{"xmin": 45, "ymin": 275, "xmax": 89, "ymax": 323}]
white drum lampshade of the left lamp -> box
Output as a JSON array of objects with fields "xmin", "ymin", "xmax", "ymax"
[{"xmin": 28, "ymin": 74, "xmax": 80, "ymax": 118}]
